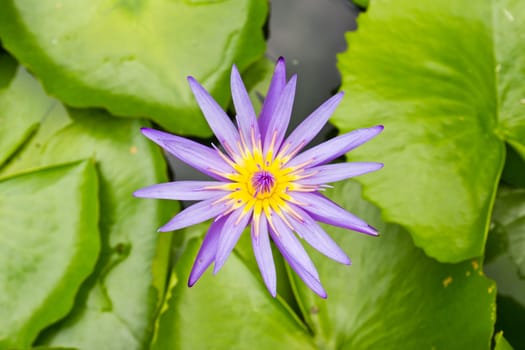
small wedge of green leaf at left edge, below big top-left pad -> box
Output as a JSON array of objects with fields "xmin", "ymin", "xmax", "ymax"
[{"xmin": 0, "ymin": 53, "xmax": 56, "ymax": 166}]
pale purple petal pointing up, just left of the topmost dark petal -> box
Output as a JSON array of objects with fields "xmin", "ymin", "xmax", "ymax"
[{"xmin": 231, "ymin": 65, "xmax": 261, "ymax": 147}]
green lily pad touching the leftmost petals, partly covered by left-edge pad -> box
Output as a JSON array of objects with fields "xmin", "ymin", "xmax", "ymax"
[{"xmin": 0, "ymin": 76, "xmax": 178, "ymax": 350}]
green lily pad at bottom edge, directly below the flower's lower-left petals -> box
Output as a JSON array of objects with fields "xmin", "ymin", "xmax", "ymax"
[{"xmin": 152, "ymin": 238, "xmax": 314, "ymax": 350}]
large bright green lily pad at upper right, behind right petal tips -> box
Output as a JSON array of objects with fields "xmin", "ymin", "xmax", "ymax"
[{"xmin": 333, "ymin": 0, "xmax": 525, "ymax": 262}]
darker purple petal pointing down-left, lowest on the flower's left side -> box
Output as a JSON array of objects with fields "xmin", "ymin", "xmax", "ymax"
[{"xmin": 188, "ymin": 217, "xmax": 226, "ymax": 287}]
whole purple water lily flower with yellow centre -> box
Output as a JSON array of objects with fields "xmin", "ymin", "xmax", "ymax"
[{"xmin": 135, "ymin": 58, "xmax": 383, "ymax": 298}]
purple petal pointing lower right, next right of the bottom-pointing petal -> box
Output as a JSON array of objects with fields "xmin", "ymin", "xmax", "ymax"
[{"xmin": 270, "ymin": 216, "xmax": 326, "ymax": 298}]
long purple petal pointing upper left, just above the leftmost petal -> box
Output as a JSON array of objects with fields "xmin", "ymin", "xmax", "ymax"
[{"xmin": 141, "ymin": 128, "xmax": 234, "ymax": 180}]
